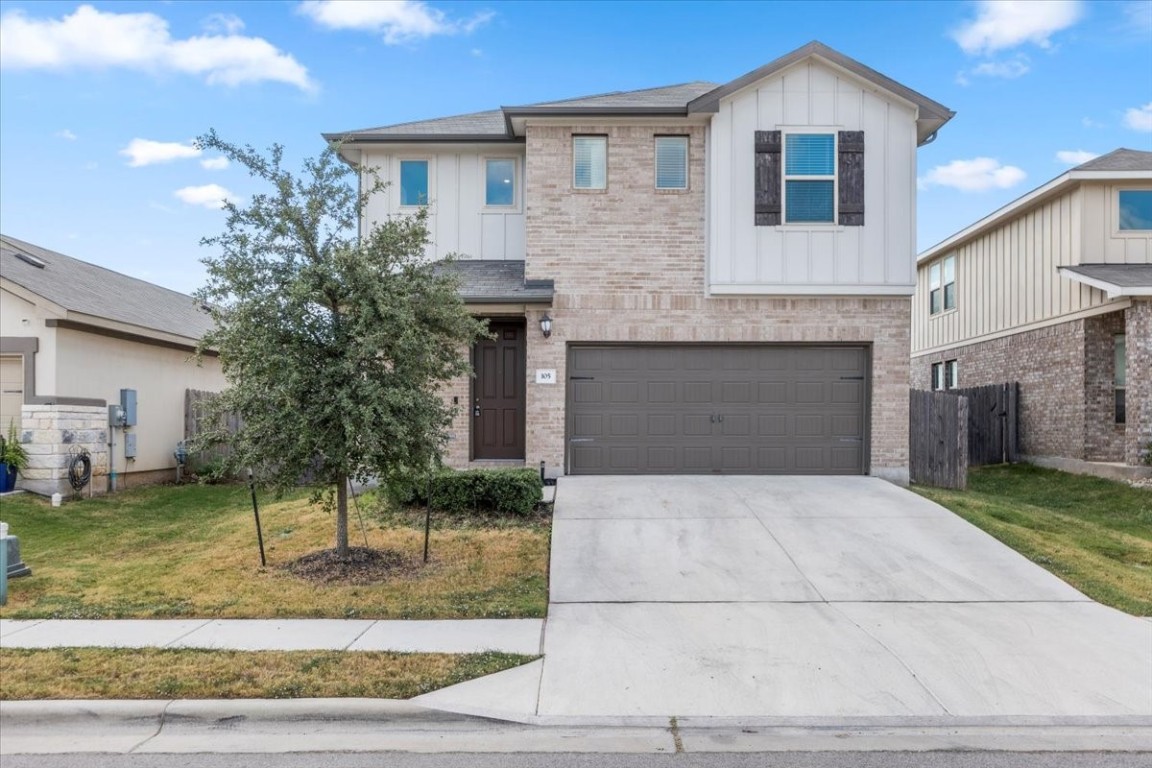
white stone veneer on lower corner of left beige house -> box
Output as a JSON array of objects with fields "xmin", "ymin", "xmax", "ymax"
[{"xmin": 16, "ymin": 405, "xmax": 108, "ymax": 496}]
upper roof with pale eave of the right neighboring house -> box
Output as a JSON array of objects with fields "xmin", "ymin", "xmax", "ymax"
[{"xmin": 916, "ymin": 147, "xmax": 1152, "ymax": 264}]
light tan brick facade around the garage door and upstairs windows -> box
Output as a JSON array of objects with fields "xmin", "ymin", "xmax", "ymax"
[{"xmin": 435, "ymin": 124, "xmax": 911, "ymax": 479}]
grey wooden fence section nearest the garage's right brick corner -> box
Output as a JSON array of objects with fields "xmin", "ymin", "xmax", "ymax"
[{"xmin": 908, "ymin": 389, "xmax": 968, "ymax": 491}]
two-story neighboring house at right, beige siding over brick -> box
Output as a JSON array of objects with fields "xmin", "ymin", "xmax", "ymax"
[{"xmin": 912, "ymin": 149, "xmax": 1152, "ymax": 469}]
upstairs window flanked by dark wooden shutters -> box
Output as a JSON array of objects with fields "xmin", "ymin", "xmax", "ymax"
[{"xmin": 785, "ymin": 134, "xmax": 836, "ymax": 225}]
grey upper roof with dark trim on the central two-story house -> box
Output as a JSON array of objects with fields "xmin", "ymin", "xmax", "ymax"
[{"xmin": 323, "ymin": 41, "xmax": 955, "ymax": 144}]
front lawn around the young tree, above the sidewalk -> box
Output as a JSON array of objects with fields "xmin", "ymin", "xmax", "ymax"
[{"xmin": 0, "ymin": 485, "xmax": 550, "ymax": 618}]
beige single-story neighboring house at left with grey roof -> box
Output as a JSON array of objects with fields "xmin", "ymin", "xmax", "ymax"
[{"xmin": 0, "ymin": 235, "xmax": 225, "ymax": 494}]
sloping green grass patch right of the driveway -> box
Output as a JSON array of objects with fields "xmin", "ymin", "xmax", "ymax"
[{"xmin": 914, "ymin": 464, "xmax": 1152, "ymax": 616}]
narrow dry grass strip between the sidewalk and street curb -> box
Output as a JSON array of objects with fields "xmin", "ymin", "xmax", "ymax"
[{"xmin": 0, "ymin": 648, "xmax": 535, "ymax": 701}]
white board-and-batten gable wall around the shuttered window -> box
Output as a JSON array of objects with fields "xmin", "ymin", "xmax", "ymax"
[{"xmin": 707, "ymin": 61, "xmax": 916, "ymax": 296}]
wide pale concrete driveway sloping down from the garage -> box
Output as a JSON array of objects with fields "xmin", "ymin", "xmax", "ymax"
[{"xmin": 420, "ymin": 477, "xmax": 1152, "ymax": 723}]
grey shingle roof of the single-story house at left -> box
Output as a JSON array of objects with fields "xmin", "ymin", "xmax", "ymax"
[{"xmin": 0, "ymin": 235, "xmax": 212, "ymax": 340}]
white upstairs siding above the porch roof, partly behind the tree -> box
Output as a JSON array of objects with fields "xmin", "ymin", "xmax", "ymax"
[{"xmin": 363, "ymin": 145, "xmax": 525, "ymax": 260}]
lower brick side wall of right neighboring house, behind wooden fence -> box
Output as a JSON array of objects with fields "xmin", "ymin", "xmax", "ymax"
[{"xmin": 912, "ymin": 320, "xmax": 1084, "ymax": 459}]
